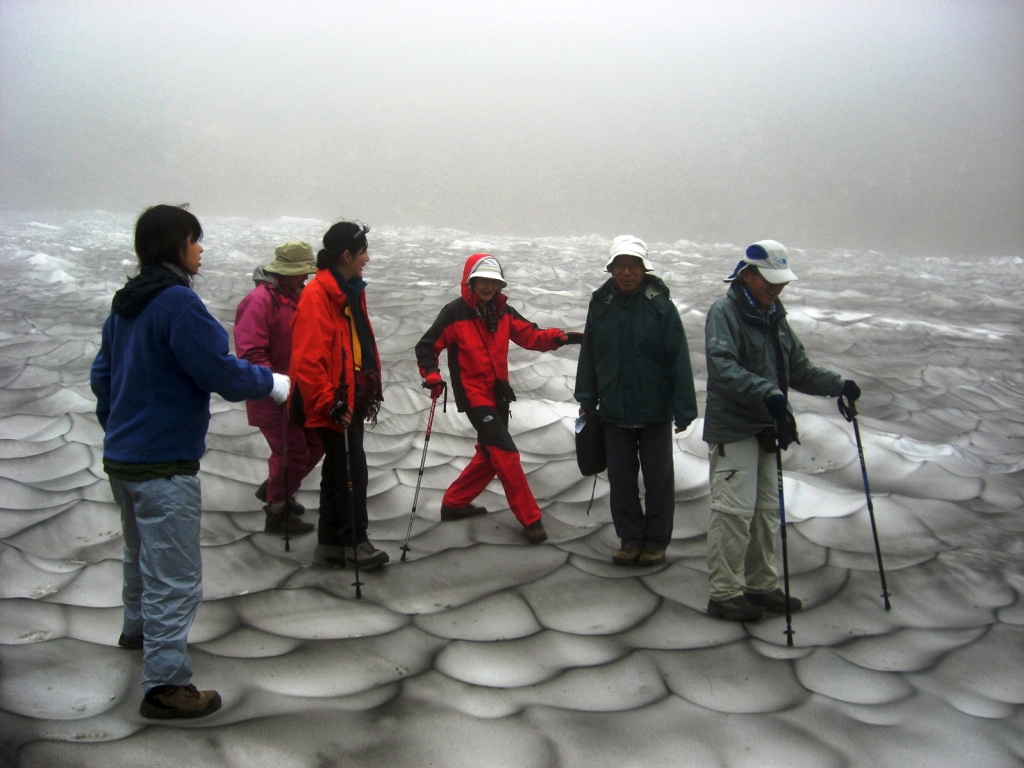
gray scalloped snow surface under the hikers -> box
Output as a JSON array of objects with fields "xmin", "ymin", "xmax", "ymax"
[{"xmin": 0, "ymin": 212, "xmax": 1024, "ymax": 768}]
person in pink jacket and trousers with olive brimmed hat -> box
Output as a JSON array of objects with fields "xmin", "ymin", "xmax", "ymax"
[{"xmin": 234, "ymin": 241, "xmax": 324, "ymax": 534}]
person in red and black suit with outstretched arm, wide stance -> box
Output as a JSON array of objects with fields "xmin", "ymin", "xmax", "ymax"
[{"xmin": 416, "ymin": 253, "xmax": 583, "ymax": 544}]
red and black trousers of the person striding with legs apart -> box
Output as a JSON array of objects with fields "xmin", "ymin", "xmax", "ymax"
[{"xmin": 441, "ymin": 406, "xmax": 541, "ymax": 525}]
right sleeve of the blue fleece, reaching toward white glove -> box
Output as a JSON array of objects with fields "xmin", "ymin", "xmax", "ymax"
[{"xmin": 171, "ymin": 289, "xmax": 273, "ymax": 402}]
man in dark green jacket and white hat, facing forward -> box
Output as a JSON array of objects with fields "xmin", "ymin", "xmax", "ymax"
[{"xmin": 573, "ymin": 234, "xmax": 697, "ymax": 565}]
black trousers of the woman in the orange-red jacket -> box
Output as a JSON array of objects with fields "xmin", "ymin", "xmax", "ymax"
[{"xmin": 316, "ymin": 428, "xmax": 370, "ymax": 547}]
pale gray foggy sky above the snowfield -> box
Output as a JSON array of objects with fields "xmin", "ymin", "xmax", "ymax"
[{"xmin": 0, "ymin": 0, "xmax": 1024, "ymax": 255}]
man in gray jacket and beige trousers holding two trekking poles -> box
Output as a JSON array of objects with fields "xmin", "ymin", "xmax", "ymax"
[{"xmin": 703, "ymin": 240, "xmax": 860, "ymax": 622}]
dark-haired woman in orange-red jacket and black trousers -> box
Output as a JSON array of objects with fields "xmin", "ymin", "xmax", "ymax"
[{"xmin": 290, "ymin": 221, "xmax": 390, "ymax": 569}]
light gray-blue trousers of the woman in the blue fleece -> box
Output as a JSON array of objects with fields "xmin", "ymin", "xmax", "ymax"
[{"xmin": 111, "ymin": 475, "xmax": 203, "ymax": 692}]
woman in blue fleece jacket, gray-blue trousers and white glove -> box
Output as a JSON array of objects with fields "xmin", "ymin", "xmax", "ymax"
[{"xmin": 90, "ymin": 205, "xmax": 289, "ymax": 719}]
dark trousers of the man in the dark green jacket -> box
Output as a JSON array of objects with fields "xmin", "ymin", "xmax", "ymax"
[{"xmin": 604, "ymin": 421, "xmax": 676, "ymax": 548}]
